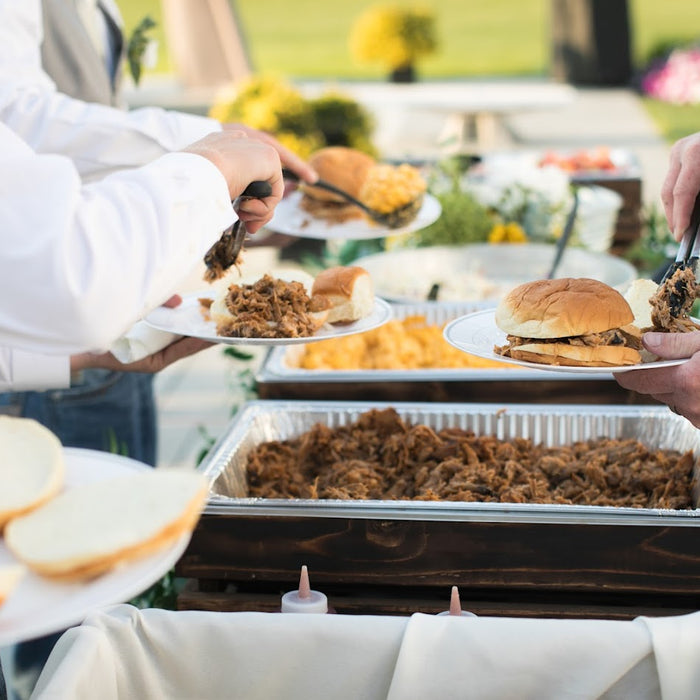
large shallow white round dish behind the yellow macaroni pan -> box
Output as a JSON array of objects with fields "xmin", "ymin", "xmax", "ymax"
[{"xmin": 352, "ymin": 243, "xmax": 638, "ymax": 303}]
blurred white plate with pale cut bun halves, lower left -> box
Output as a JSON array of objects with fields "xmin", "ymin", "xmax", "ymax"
[{"xmin": 0, "ymin": 417, "xmax": 208, "ymax": 646}]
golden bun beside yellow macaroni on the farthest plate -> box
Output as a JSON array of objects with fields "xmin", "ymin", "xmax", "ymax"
[{"xmin": 300, "ymin": 146, "xmax": 376, "ymax": 206}]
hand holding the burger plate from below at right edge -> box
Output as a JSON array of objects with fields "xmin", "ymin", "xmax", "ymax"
[{"xmin": 614, "ymin": 331, "xmax": 700, "ymax": 428}]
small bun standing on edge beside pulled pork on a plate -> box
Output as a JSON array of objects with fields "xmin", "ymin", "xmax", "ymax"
[{"xmin": 311, "ymin": 266, "xmax": 374, "ymax": 323}]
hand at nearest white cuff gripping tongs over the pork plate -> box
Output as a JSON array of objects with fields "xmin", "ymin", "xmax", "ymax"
[{"xmin": 182, "ymin": 129, "xmax": 284, "ymax": 233}]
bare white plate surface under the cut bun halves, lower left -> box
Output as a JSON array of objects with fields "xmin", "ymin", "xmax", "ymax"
[{"xmin": 0, "ymin": 447, "xmax": 190, "ymax": 647}]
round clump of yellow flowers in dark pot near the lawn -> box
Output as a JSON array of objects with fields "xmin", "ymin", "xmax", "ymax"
[{"xmin": 349, "ymin": 5, "xmax": 437, "ymax": 76}]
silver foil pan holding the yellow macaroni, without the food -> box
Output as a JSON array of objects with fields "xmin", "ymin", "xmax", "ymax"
[{"xmin": 256, "ymin": 301, "xmax": 612, "ymax": 384}]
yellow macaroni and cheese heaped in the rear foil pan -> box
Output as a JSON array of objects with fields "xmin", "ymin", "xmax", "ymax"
[{"xmin": 298, "ymin": 316, "xmax": 509, "ymax": 370}]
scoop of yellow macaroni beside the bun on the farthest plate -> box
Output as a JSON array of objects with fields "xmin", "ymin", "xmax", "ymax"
[{"xmin": 359, "ymin": 163, "xmax": 426, "ymax": 214}]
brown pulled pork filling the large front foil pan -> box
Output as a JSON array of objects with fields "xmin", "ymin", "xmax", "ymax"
[{"xmin": 247, "ymin": 408, "xmax": 695, "ymax": 509}]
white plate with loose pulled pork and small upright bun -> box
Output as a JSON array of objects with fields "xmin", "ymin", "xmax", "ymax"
[{"xmin": 145, "ymin": 266, "xmax": 392, "ymax": 345}]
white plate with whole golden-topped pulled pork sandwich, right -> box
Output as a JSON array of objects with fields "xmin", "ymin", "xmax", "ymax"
[{"xmin": 444, "ymin": 278, "xmax": 700, "ymax": 374}]
